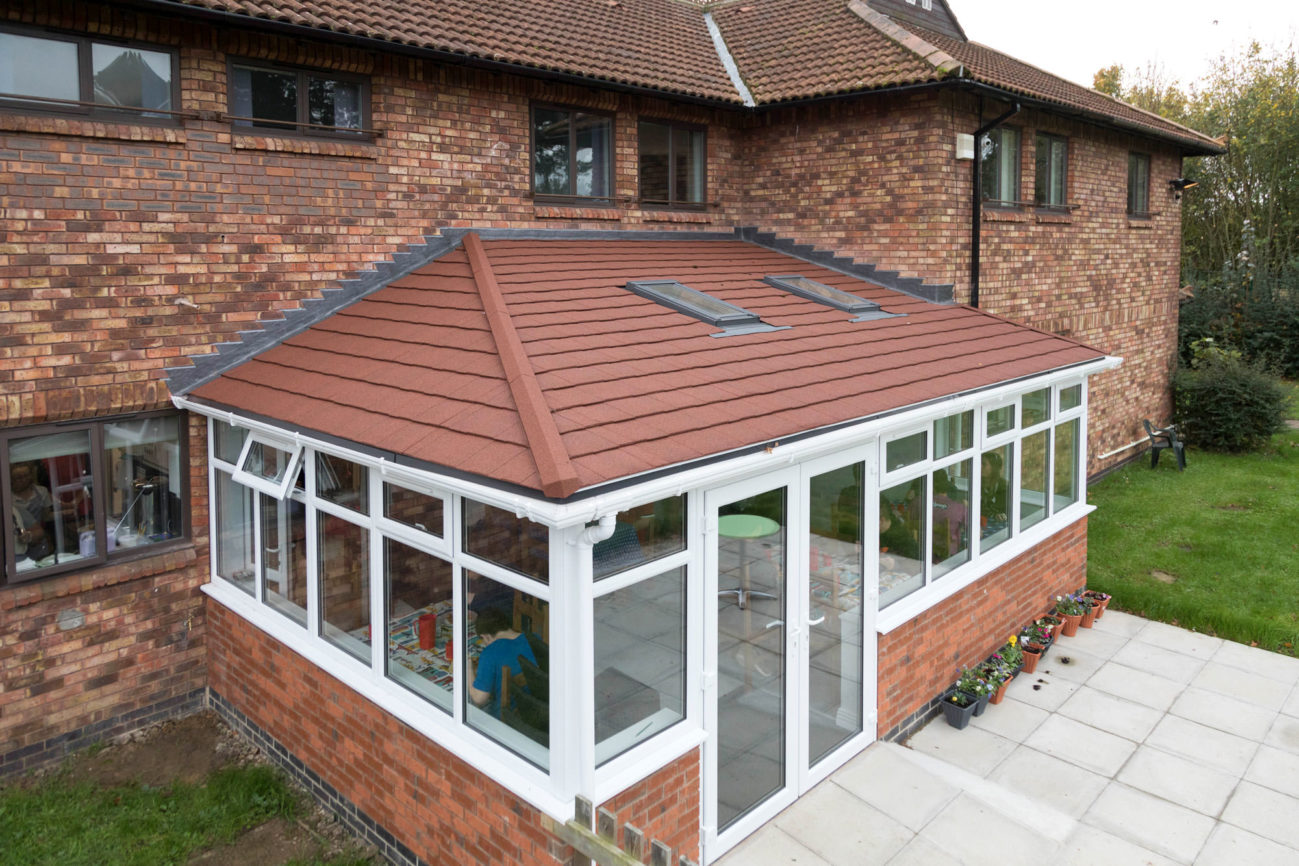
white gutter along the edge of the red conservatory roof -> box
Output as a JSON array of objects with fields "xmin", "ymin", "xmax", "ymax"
[{"xmin": 171, "ymin": 356, "xmax": 1122, "ymax": 535}]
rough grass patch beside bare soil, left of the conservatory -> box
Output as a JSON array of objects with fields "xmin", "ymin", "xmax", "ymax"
[{"xmin": 0, "ymin": 766, "xmax": 297, "ymax": 866}]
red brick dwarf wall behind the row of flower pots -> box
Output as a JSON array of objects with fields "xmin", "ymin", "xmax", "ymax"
[{"xmin": 877, "ymin": 519, "xmax": 1087, "ymax": 737}]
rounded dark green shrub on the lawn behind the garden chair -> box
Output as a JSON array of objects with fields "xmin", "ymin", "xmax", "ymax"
[{"xmin": 1173, "ymin": 341, "xmax": 1286, "ymax": 452}]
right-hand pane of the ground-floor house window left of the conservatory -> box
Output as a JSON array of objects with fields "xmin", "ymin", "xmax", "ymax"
[{"xmin": 104, "ymin": 415, "xmax": 187, "ymax": 551}]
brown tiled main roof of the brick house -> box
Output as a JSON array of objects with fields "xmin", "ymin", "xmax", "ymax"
[{"xmin": 151, "ymin": 0, "xmax": 1221, "ymax": 153}]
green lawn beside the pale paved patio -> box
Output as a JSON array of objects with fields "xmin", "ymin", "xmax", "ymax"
[{"xmin": 1087, "ymin": 423, "xmax": 1299, "ymax": 656}]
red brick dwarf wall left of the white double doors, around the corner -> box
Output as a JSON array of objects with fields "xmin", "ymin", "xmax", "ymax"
[{"xmin": 209, "ymin": 601, "xmax": 700, "ymax": 866}]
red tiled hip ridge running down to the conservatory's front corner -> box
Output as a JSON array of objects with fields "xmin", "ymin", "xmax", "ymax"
[{"xmin": 462, "ymin": 231, "xmax": 582, "ymax": 499}]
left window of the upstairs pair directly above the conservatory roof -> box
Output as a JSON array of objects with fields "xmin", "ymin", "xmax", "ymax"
[{"xmin": 533, "ymin": 105, "xmax": 613, "ymax": 199}]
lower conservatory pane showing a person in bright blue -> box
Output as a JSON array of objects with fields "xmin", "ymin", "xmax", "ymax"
[{"xmin": 460, "ymin": 571, "xmax": 551, "ymax": 770}]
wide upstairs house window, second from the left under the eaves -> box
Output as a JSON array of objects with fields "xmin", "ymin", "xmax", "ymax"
[{"xmin": 230, "ymin": 61, "xmax": 369, "ymax": 136}]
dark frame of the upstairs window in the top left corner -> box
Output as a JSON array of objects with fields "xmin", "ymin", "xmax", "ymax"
[{"xmin": 0, "ymin": 22, "xmax": 184, "ymax": 126}]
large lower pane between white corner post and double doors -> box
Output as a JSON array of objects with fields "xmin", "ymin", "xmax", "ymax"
[{"xmin": 595, "ymin": 567, "xmax": 686, "ymax": 765}]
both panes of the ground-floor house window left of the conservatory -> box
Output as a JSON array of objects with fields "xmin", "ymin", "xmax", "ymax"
[{"xmin": 0, "ymin": 413, "xmax": 188, "ymax": 583}]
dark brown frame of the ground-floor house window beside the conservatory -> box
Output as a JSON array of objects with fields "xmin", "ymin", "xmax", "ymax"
[{"xmin": 0, "ymin": 409, "xmax": 194, "ymax": 589}]
